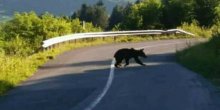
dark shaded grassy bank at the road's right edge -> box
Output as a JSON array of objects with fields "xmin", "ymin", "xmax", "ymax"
[{"xmin": 176, "ymin": 37, "xmax": 220, "ymax": 88}]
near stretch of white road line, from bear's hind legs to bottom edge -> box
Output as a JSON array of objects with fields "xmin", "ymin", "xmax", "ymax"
[{"xmin": 85, "ymin": 59, "xmax": 115, "ymax": 110}]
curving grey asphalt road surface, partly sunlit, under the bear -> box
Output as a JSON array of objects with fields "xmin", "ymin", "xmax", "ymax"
[{"xmin": 0, "ymin": 40, "xmax": 220, "ymax": 110}]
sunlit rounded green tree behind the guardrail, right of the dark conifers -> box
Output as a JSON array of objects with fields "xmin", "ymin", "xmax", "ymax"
[{"xmin": 123, "ymin": 0, "xmax": 162, "ymax": 29}]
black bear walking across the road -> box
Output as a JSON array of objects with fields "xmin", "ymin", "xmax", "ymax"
[{"xmin": 114, "ymin": 48, "xmax": 147, "ymax": 68}]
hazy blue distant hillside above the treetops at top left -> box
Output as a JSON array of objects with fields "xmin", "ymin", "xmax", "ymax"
[{"xmin": 0, "ymin": 0, "xmax": 136, "ymax": 16}]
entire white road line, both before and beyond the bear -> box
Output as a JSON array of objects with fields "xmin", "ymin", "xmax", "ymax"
[{"xmin": 85, "ymin": 42, "xmax": 184, "ymax": 110}]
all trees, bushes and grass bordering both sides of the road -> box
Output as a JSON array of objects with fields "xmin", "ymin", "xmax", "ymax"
[{"xmin": 0, "ymin": 0, "xmax": 220, "ymax": 95}]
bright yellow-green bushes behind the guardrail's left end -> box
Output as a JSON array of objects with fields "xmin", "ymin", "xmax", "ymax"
[{"xmin": 0, "ymin": 12, "xmax": 101, "ymax": 56}]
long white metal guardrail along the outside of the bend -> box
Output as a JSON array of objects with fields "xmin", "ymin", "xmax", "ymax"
[{"xmin": 42, "ymin": 29, "xmax": 195, "ymax": 48}]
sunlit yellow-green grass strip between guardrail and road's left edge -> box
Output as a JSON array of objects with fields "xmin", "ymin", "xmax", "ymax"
[{"xmin": 0, "ymin": 35, "xmax": 203, "ymax": 96}]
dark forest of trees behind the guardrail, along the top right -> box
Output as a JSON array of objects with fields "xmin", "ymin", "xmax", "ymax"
[{"xmin": 71, "ymin": 0, "xmax": 220, "ymax": 30}]
